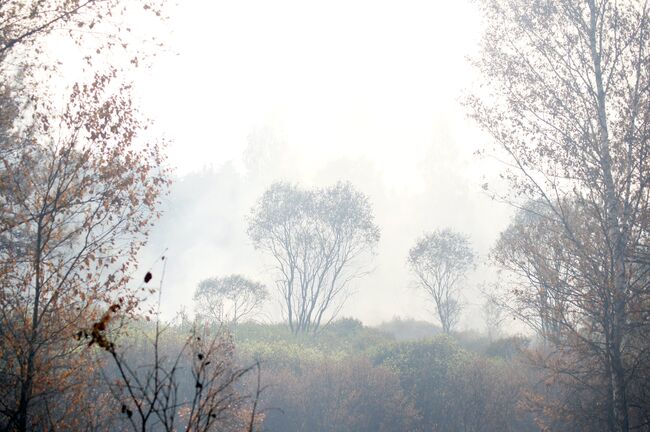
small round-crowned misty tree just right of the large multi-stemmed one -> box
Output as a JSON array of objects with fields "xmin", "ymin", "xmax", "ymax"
[{"xmin": 408, "ymin": 229, "xmax": 474, "ymax": 333}]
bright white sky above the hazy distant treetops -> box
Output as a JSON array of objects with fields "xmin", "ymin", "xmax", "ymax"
[{"xmin": 138, "ymin": 0, "xmax": 480, "ymax": 186}]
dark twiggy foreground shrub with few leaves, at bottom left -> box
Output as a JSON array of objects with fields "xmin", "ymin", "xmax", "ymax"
[{"xmin": 77, "ymin": 303, "xmax": 264, "ymax": 432}]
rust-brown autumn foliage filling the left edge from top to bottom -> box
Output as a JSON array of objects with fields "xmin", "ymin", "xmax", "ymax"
[{"xmin": 0, "ymin": 0, "xmax": 168, "ymax": 430}]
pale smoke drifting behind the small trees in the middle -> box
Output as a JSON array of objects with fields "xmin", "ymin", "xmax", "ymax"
[{"xmin": 141, "ymin": 110, "xmax": 510, "ymax": 328}]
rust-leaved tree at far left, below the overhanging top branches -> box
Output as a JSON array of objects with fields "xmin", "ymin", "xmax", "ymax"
[{"xmin": 0, "ymin": 70, "xmax": 168, "ymax": 428}]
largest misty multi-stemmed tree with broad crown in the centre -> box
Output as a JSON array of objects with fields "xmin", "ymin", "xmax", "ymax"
[{"xmin": 248, "ymin": 183, "xmax": 379, "ymax": 333}]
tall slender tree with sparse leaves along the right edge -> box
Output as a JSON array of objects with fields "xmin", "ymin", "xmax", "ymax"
[{"xmin": 469, "ymin": 0, "xmax": 650, "ymax": 431}]
